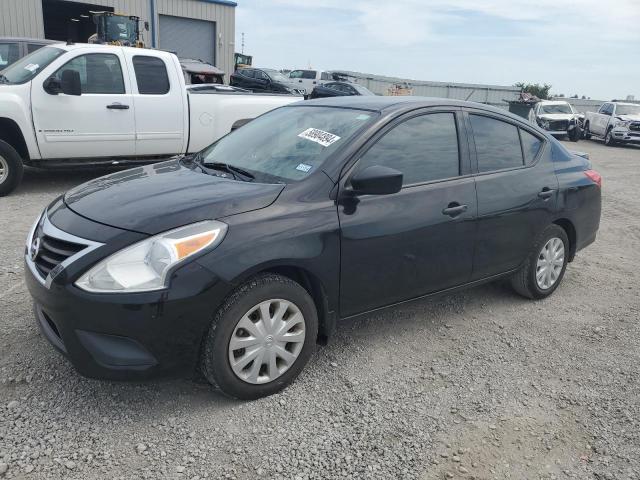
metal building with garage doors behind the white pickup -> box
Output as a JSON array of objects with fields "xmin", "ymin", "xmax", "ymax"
[{"xmin": 0, "ymin": 0, "xmax": 236, "ymax": 79}]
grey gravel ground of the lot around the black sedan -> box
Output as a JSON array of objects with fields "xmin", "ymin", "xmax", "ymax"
[{"xmin": 0, "ymin": 141, "xmax": 640, "ymax": 480}]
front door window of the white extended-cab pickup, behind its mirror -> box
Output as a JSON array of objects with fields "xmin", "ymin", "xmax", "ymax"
[{"xmin": 54, "ymin": 53, "xmax": 125, "ymax": 95}]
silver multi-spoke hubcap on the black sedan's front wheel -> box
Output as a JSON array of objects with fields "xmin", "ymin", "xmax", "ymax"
[{"xmin": 229, "ymin": 299, "xmax": 305, "ymax": 384}]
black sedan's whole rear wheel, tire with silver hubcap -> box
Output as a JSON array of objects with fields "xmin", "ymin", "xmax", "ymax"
[{"xmin": 511, "ymin": 225, "xmax": 569, "ymax": 300}]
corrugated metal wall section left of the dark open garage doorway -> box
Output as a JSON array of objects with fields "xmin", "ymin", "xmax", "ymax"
[{"xmin": 0, "ymin": 0, "xmax": 44, "ymax": 38}]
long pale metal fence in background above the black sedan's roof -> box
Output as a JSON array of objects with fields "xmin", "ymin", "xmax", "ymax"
[{"xmin": 332, "ymin": 70, "xmax": 520, "ymax": 109}]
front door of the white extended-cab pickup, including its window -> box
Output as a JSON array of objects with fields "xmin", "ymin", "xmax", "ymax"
[{"xmin": 31, "ymin": 50, "xmax": 136, "ymax": 159}]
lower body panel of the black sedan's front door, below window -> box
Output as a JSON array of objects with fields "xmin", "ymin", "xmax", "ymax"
[{"xmin": 339, "ymin": 178, "xmax": 476, "ymax": 316}]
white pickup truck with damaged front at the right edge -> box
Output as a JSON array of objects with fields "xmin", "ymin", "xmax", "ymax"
[{"xmin": 584, "ymin": 102, "xmax": 640, "ymax": 146}]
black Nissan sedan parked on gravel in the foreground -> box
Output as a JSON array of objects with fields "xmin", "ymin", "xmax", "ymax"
[{"xmin": 25, "ymin": 97, "xmax": 601, "ymax": 399}]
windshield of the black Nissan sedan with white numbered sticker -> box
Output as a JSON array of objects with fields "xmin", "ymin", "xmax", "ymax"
[{"xmin": 200, "ymin": 106, "xmax": 377, "ymax": 183}]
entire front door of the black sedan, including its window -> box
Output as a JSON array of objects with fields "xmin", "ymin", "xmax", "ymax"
[{"xmin": 338, "ymin": 111, "xmax": 476, "ymax": 316}]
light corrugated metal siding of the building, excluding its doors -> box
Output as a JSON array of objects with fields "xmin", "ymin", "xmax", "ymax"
[{"xmin": 0, "ymin": 0, "xmax": 236, "ymax": 79}]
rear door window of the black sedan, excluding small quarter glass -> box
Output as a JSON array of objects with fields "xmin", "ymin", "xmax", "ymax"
[{"xmin": 470, "ymin": 115, "xmax": 523, "ymax": 172}]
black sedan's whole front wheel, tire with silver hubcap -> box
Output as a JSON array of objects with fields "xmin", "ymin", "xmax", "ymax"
[{"xmin": 200, "ymin": 273, "xmax": 318, "ymax": 400}]
